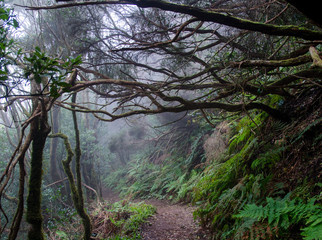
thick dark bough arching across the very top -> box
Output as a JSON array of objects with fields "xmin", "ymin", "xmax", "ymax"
[{"xmin": 23, "ymin": 0, "xmax": 322, "ymax": 40}]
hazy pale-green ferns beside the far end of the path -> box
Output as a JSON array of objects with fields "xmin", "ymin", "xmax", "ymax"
[{"xmin": 105, "ymin": 133, "xmax": 203, "ymax": 200}]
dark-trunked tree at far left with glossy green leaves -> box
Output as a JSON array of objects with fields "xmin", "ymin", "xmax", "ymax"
[{"xmin": 0, "ymin": 9, "xmax": 80, "ymax": 236}]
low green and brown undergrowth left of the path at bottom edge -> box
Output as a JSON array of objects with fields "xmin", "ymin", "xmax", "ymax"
[{"xmin": 47, "ymin": 200, "xmax": 156, "ymax": 240}]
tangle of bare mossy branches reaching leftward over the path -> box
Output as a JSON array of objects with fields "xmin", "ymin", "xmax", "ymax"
[{"xmin": 18, "ymin": 0, "xmax": 322, "ymax": 124}]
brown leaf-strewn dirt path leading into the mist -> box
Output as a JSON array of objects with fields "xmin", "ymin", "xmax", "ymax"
[{"xmin": 104, "ymin": 191, "xmax": 211, "ymax": 240}]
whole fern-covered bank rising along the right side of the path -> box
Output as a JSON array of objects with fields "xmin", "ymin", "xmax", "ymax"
[{"xmin": 107, "ymin": 88, "xmax": 322, "ymax": 240}]
